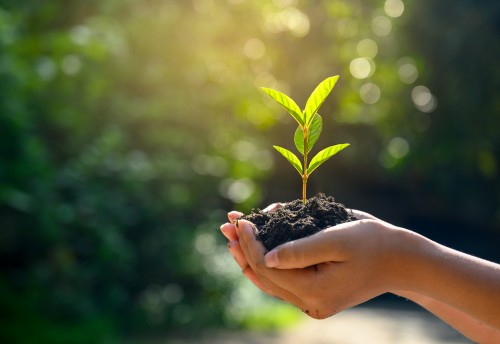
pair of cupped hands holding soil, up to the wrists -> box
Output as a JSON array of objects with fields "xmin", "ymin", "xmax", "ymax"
[{"xmin": 221, "ymin": 204, "xmax": 406, "ymax": 319}]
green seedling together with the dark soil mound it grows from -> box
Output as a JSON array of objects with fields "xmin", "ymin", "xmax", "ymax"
[{"xmin": 243, "ymin": 75, "xmax": 353, "ymax": 250}]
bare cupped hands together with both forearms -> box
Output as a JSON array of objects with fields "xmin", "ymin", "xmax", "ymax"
[{"xmin": 221, "ymin": 208, "xmax": 500, "ymax": 343}]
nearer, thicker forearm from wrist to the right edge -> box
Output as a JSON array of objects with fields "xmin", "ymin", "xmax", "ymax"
[{"xmin": 399, "ymin": 232, "xmax": 500, "ymax": 329}]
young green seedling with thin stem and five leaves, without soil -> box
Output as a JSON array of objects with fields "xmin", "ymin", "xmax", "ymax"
[{"xmin": 261, "ymin": 75, "xmax": 349, "ymax": 204}]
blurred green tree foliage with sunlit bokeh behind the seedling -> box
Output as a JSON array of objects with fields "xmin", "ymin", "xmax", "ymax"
[{"xmin": 0, "ymin": 0, "xmax": 500, "ymax": 343}]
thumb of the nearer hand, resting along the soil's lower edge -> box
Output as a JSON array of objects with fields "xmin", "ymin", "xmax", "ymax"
[{"xmin": 264, "ymin": 228, "xmax": 343, "ymax": 269}]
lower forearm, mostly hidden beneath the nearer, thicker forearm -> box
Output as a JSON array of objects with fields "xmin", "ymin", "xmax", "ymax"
[{"xmin": 395, "ymin": 291, "xmax": 500, "ymax": 344}]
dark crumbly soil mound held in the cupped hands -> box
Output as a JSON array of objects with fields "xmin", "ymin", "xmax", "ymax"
[{"xmin": 242, "ymin": 194, "xmax": 356, "ymax": 251}]
